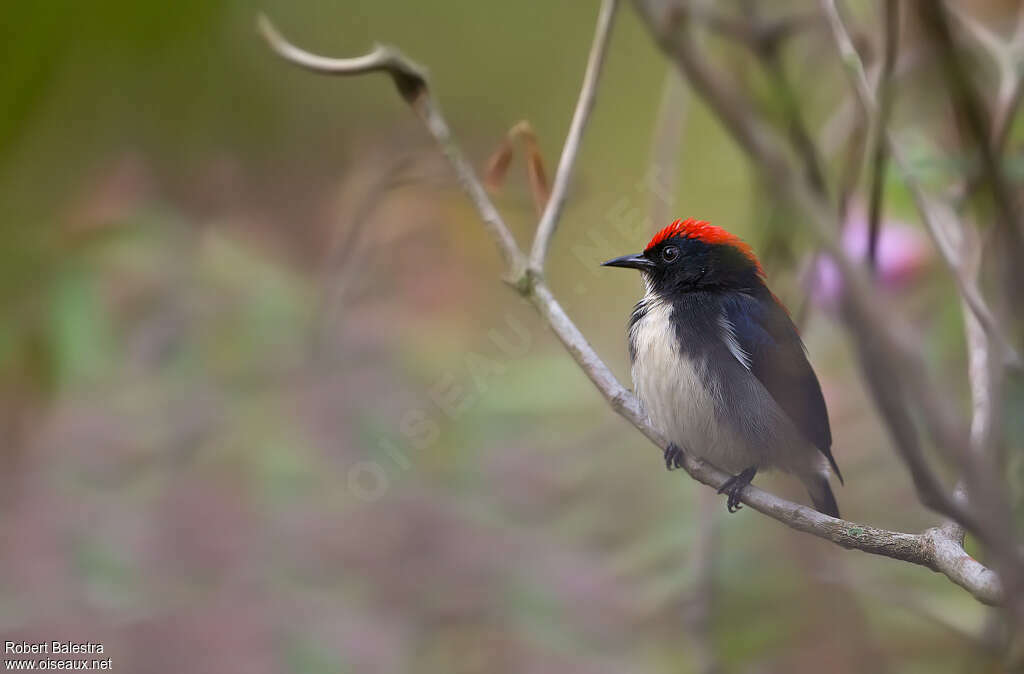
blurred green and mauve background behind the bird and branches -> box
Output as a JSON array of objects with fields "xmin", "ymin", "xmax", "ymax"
[{"xmin": 0, "ymin": 0, "xmax": 995, "ymax": 673}]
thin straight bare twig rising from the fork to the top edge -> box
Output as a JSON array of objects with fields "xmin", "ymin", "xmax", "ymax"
[{"xmin": 529, "ymin": 0, "xmax": 618, "ymax": 273}]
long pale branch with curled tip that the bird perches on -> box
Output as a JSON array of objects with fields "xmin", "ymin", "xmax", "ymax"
[{"xmin": 260, "ymin": 10, "xmax": 1004, "ymax": 604}]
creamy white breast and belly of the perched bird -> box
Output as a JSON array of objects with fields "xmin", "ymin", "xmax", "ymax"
[{"xmin": 630, "ymin": 294, "xmax": 758, "ymax": 473}]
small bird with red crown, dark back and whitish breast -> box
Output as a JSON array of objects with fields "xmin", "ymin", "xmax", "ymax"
[{"xmin": 603, "ymin": 218, "xmax": 843, "ymax": 517}]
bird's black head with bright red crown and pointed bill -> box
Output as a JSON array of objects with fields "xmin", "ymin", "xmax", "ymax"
[{"xmin": 602, "ymin": 219, "xmax": 763, "ymax": 296}]
